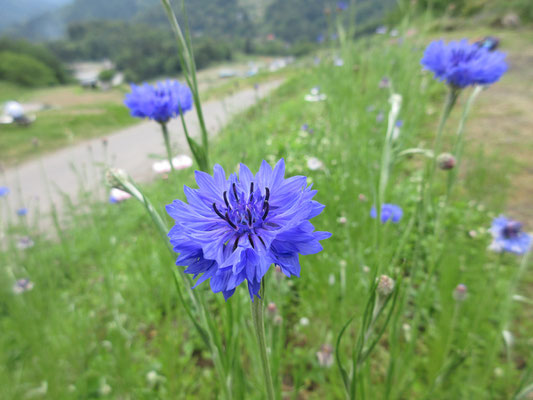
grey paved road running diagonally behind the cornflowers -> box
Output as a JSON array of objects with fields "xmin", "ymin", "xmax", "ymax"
[{"xmin": 0, "ymin": 80, "xmax": 282, "ymax": 226}]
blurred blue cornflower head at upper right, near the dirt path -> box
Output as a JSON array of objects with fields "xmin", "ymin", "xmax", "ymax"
[{"xmin": 421, "ymin": 39, "xmax": 507, "ymax": 88}]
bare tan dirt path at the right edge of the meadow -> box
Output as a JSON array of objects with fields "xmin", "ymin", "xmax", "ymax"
[{"xmin": 467, "ymin": 31, "xmax": 533, "ymax": 225}]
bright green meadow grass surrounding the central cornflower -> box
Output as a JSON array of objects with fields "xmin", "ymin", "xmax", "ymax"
[{"xmin": 0, "ymin": 25, "xmax": 533, "ymax": 400}]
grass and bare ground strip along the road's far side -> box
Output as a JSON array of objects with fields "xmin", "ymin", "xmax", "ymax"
[{"xmin": 0, "ymin": 57, "xmax": 294, "ymax": 168}]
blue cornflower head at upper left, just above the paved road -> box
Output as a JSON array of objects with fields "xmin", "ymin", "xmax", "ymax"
[{"xmin": 124, "ymin": 80, "xmax": 192, "ymax": 123}]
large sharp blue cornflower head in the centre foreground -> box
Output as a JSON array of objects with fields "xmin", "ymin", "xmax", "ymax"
[{"xmin": 166, "ymin": 160, "xmax": 331, "ymax": 301}]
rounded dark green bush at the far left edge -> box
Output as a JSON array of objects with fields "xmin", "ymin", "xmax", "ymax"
[{"xmin": 0, "ymin": 51, "xmax": 58, "ymax": 87}]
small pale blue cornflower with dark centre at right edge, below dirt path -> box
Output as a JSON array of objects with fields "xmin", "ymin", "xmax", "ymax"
[{"xmin": 490, "ymin": 215, "xmax": 531, "ymax": 254}]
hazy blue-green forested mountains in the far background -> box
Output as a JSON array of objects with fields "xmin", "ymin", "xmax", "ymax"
[{"xmin": 7, "ymin": 0, "xmax": 395, "ymax": 42}]
